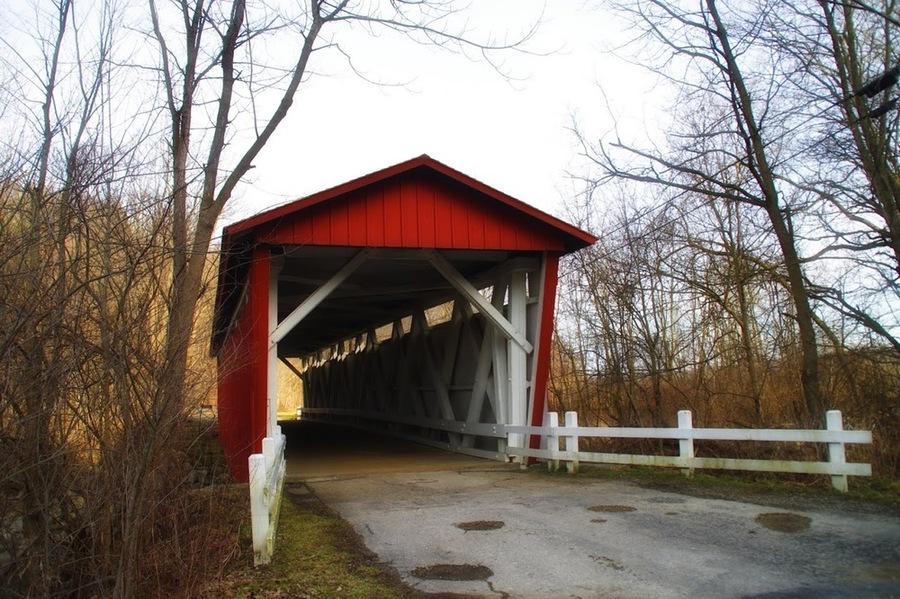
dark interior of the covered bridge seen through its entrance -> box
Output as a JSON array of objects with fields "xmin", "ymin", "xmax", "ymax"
[{"xmin": 276, "ymin": 247, "xmax": 542, "ymax": 461}]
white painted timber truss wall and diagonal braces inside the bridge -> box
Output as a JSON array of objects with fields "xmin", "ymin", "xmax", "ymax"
[{"xmin": 269, "ymin": 252, "xmax": 543, "ymax": 460}]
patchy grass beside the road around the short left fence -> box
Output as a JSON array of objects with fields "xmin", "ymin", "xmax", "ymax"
[{"xmin": 203, "ymin": 485, "xmax": 414, "ymax": 599}]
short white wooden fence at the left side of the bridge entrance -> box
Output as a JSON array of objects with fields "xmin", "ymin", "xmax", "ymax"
[{"xmin": 249, "ymin": 426, "xmax": 285, "ymax": 566}]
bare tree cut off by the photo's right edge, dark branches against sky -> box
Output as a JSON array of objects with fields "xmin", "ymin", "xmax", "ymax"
[{"xmin": 768, "ymin": 0, "xmax": 900, "ymax": 351}]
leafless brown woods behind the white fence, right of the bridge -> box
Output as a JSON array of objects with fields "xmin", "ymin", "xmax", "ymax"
[{"xmin": 556, "ymin": 0, "xmax": 900, "ymax": 474}]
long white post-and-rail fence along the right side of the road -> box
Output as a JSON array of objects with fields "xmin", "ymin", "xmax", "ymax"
[{"xmin": 506, "ymin": 410, "xmax": 872, "ymax": 492}]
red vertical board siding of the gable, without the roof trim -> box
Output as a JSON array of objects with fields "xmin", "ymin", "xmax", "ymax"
[{"xmin": 258, "ymin": 171, "xmax": 565, "ymax": 251}]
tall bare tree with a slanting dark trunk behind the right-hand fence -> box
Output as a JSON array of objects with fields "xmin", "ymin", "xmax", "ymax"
[{"xmin": 585, "ymin": 0, "xmax": 826, "ymax": 423}]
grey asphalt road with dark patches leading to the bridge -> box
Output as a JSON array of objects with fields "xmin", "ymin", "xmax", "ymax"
[{"xmin": 289, "ymin": 424, "xmax": 900, "ymax": 599}]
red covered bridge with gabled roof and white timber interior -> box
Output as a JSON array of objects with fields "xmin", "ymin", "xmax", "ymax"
[{"xmin": 212, "ymin": 156, "xmax": 596, "ymax": 480}]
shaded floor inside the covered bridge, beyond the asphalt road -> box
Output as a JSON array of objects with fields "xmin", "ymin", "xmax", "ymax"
[{"xmin": 279, "ymin": 421, "xmax": 506, "ymax": 481}]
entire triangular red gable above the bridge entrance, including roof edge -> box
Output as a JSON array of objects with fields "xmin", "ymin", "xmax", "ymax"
[{"xmin": 224, "ymin": 155, "xmax": 596, "ymax": 253}]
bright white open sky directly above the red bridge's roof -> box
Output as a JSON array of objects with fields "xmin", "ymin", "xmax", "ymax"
[{"xmin": 224, "ymin": 0, "xmax": 654, "ymax": 230}]
